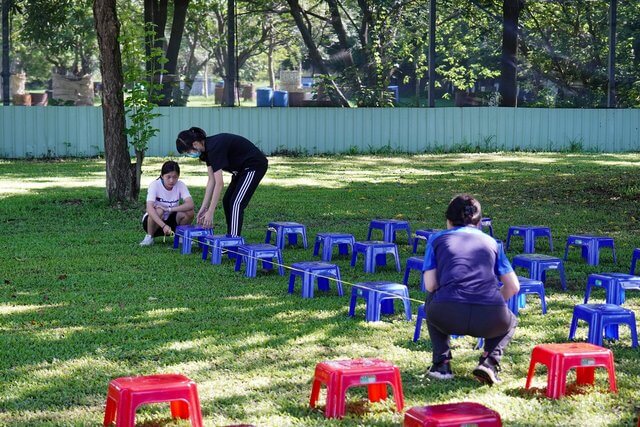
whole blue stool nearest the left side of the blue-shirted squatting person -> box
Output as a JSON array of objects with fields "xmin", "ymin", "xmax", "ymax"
[{"xmin": 349, "ymin": 282, "xmax": 411, "ymax": 322}]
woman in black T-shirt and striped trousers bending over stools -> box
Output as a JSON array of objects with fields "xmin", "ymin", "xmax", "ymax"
[{"xmin": 176, "ymin": 127, "xmax": 268, "ymax": 237}]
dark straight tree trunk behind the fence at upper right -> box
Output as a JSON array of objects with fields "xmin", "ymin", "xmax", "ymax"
[{"xmin": 500, "ymin": 0, "xmax": 523, "ymax": 107}]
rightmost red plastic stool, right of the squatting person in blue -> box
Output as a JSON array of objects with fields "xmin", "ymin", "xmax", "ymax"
[{"xmin": 524, "ymin": 343, "xmax": 618, "ymax": 399}]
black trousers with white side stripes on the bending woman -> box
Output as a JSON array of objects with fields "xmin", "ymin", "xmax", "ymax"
[{"xmin": 222, "ymin": 162, "xmax": 267, "ymax": 236}]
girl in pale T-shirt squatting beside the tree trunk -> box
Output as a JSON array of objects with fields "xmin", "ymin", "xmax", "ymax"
[{"xmin": 140, "ymin": 161, "xmax": 194, "ymax": 246}]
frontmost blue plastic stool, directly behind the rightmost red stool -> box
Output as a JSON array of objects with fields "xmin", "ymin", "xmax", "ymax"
[{"xmin": 569, "ymin": 304, "xmax": 638, "ymax": 348}]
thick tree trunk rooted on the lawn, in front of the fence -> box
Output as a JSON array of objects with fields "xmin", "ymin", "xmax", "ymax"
[{"xmin": 93, "ymin": 0, "xmax": 140, "ymax": 204}]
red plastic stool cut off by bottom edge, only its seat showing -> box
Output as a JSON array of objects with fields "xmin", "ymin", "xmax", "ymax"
[{"xmin": 403, "ymin": 402, "xmax": 502, "ymax": 427}]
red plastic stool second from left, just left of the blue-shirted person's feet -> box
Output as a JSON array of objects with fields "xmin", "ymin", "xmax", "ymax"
[{"xmin": 309, "ymin": 359, "xmax": 404, "ymax": 418}]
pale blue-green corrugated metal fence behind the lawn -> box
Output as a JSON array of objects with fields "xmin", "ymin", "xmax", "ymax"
[{"xmin": 0, "ymin": 107, "xmax": 640, "ymax": 158}]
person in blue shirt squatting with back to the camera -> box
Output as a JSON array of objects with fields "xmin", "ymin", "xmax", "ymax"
[{"xmin": 423, "ymin": 194, "xmax": 520, "ymax": 385}]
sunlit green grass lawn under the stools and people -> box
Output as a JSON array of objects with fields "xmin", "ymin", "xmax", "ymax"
[{"xmin": 0, "ymin": 153, "xmax": 640, "ymax": 426}]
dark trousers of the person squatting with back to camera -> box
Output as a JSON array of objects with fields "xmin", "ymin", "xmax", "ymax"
[{"xmin": 425, "ymin": 298, "xmax": 518, "ymax": 363}]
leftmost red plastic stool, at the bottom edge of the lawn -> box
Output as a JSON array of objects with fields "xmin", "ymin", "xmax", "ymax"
[{"xmin": 103, "ymin": 374, "xmax": 202, "ymax": 427}]
